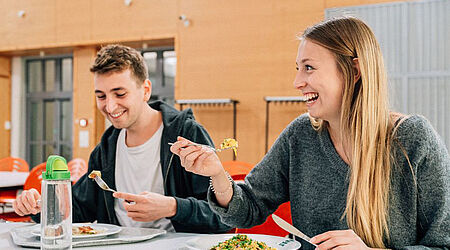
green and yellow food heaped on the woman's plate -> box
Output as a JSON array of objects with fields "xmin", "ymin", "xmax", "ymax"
[{"xmin": 210, "ymin": 234, "xmax": 275, "ymax": 250}]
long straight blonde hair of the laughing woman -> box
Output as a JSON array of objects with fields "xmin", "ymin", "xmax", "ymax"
[{"xmin": 301, "ymin": 17, "xmax": 394, "ymax": 248}]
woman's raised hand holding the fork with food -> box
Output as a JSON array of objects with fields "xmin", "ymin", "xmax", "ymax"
[{"xmin": 170, "ymin": 136, "xmax": 224, "ymax": 177}]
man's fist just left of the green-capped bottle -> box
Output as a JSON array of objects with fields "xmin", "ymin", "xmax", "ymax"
[{"xmin": 13, "ymin": 188, "xmax": 41, "ymax": 216}]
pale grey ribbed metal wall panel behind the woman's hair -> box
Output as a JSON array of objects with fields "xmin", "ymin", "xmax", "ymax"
[{"xmin": 325, "ymin": 0, "xmax": 450, "ymax": 149}]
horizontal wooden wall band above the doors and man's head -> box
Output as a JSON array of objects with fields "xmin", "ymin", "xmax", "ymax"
[{"xmin": 0, "ymin": 0, "xmax": 178, "ymax": 53}]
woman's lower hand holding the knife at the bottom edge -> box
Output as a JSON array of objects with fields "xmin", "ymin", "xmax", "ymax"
[{"xmin": 311, "ymin": 229, "xmax": 372, "ymax": 250}]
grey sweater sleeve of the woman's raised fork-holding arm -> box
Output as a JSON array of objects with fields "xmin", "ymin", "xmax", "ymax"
[{"xmin": 208, "ymin": 121, "xmax": 290, "ymax": 228}]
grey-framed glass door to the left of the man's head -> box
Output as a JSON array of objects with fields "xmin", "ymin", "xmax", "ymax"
[{"xmin": 25, "ymin": 57, "xmax": 72, "ymax": 167}]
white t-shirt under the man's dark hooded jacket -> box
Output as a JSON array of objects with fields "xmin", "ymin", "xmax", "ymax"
[{"xmin": 114, "ymin": 125, "xmax": 175, "ymax": 232}]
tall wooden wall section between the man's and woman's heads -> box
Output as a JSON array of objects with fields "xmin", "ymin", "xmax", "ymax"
[{"xmin": 175, "ymin": 0, "xmax": 324, "ymax": 164}]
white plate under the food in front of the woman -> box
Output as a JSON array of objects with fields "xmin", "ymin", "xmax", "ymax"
[{"xmin": 186, "ymin": 234, "xmax": 301, "ymax": 250}]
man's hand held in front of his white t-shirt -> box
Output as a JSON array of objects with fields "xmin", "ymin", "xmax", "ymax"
[{"xmin": 113, "ymin": 191, "xmax": 177, "ymax": 222}]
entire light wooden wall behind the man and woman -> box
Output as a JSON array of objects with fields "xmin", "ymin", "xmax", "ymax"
[{"xmin": 0, "ymin": 0, "xmax": 408, "ymax": 164}]
